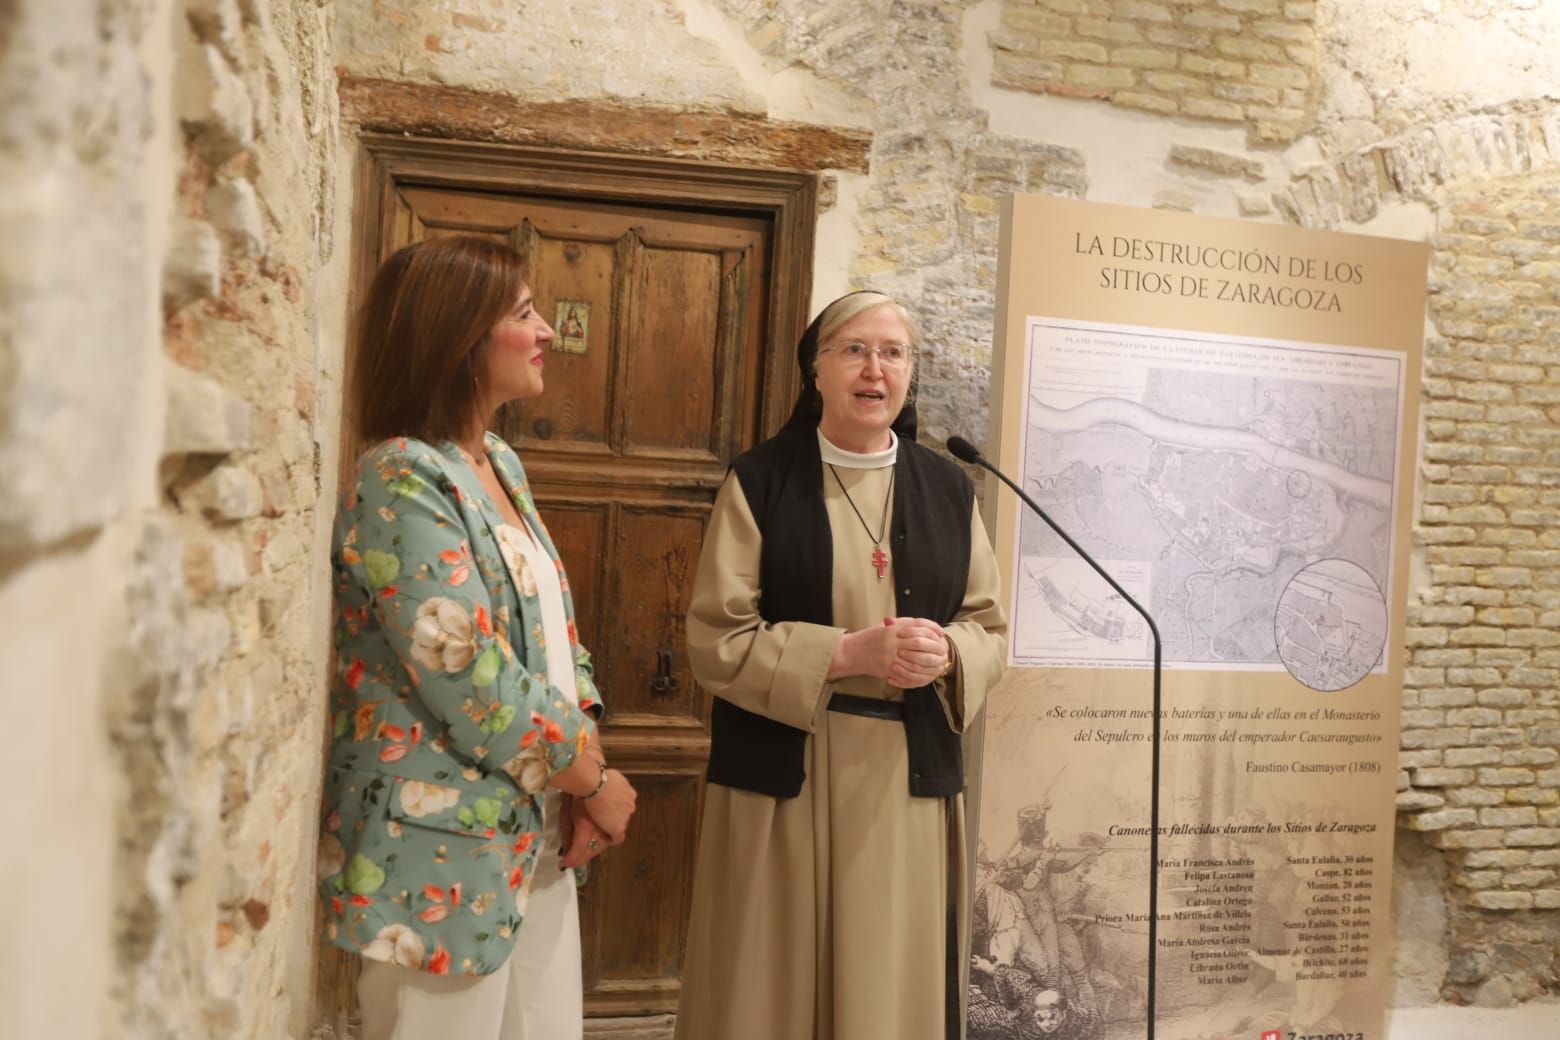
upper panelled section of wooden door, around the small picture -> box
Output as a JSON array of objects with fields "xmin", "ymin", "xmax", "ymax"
[{"xmin": 398, "ymin": 180, "xmax": 769, "ymax": 465}]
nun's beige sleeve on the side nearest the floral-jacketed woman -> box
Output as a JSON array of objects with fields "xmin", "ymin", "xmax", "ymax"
[{"xmin": 688, "ymin": 474, "xmax": 848, "ymax": 733}]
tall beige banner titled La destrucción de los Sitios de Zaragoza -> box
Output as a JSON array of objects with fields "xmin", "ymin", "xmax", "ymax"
[{"xmin": 967, "ymin": 195, "xmax": 1429, "ymax": 1040}]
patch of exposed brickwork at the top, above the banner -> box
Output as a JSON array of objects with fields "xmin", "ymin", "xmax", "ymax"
[{"xmin": 991, "ymin": 0, "xmax": 1317, "ymax": 142}]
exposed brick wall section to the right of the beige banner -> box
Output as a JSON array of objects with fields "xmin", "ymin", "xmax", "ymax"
[{"xmin": 1398, "ymin": 172, "xmax": 1560, "ymax": 911}]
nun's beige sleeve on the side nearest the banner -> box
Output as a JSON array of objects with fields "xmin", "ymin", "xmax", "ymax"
[{"xmin": 938, "ymin": 502, "xmax": 1008, "ymax": 733}]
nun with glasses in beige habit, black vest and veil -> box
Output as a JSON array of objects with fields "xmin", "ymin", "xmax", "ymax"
[{"xmin": 675, "ymin": 292, "xmax": 1008, "ymax": 1040}]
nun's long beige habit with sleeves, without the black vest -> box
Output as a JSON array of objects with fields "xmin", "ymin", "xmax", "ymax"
[{"xmin": 675, "ymin": 437, "xmax": 1006, "ymax": 1040}]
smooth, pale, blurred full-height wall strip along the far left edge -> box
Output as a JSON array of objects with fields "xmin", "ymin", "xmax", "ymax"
[{"xmin": 0, "ymin": 2, "xmax": 167, "ymax": 1037}]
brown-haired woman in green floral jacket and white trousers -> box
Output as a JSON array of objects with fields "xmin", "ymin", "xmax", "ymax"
[{"xmin": 320, "ymin": 235, "xmax": 635, "ymax": 1040}]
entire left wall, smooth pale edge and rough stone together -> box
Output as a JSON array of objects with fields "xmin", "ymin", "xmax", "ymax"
[{"xmin": 0, "ymin": 0, "xmax": 339, "ymax": 1038}]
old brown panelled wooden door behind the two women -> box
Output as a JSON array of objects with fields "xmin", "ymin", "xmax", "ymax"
[{"xmin": 351, "ymin": 137, "xmax": 810, "ymax": 1015}]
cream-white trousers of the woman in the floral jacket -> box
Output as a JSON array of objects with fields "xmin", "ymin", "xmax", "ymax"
[{"xmin": 357, "ymin": 792, "xmax": 585, "ymax": 1040}]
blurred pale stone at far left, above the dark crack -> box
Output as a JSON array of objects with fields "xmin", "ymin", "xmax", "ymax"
[{"xmin": 0, "ymin": 0, "xmax": 156, "ymax": 550}]
